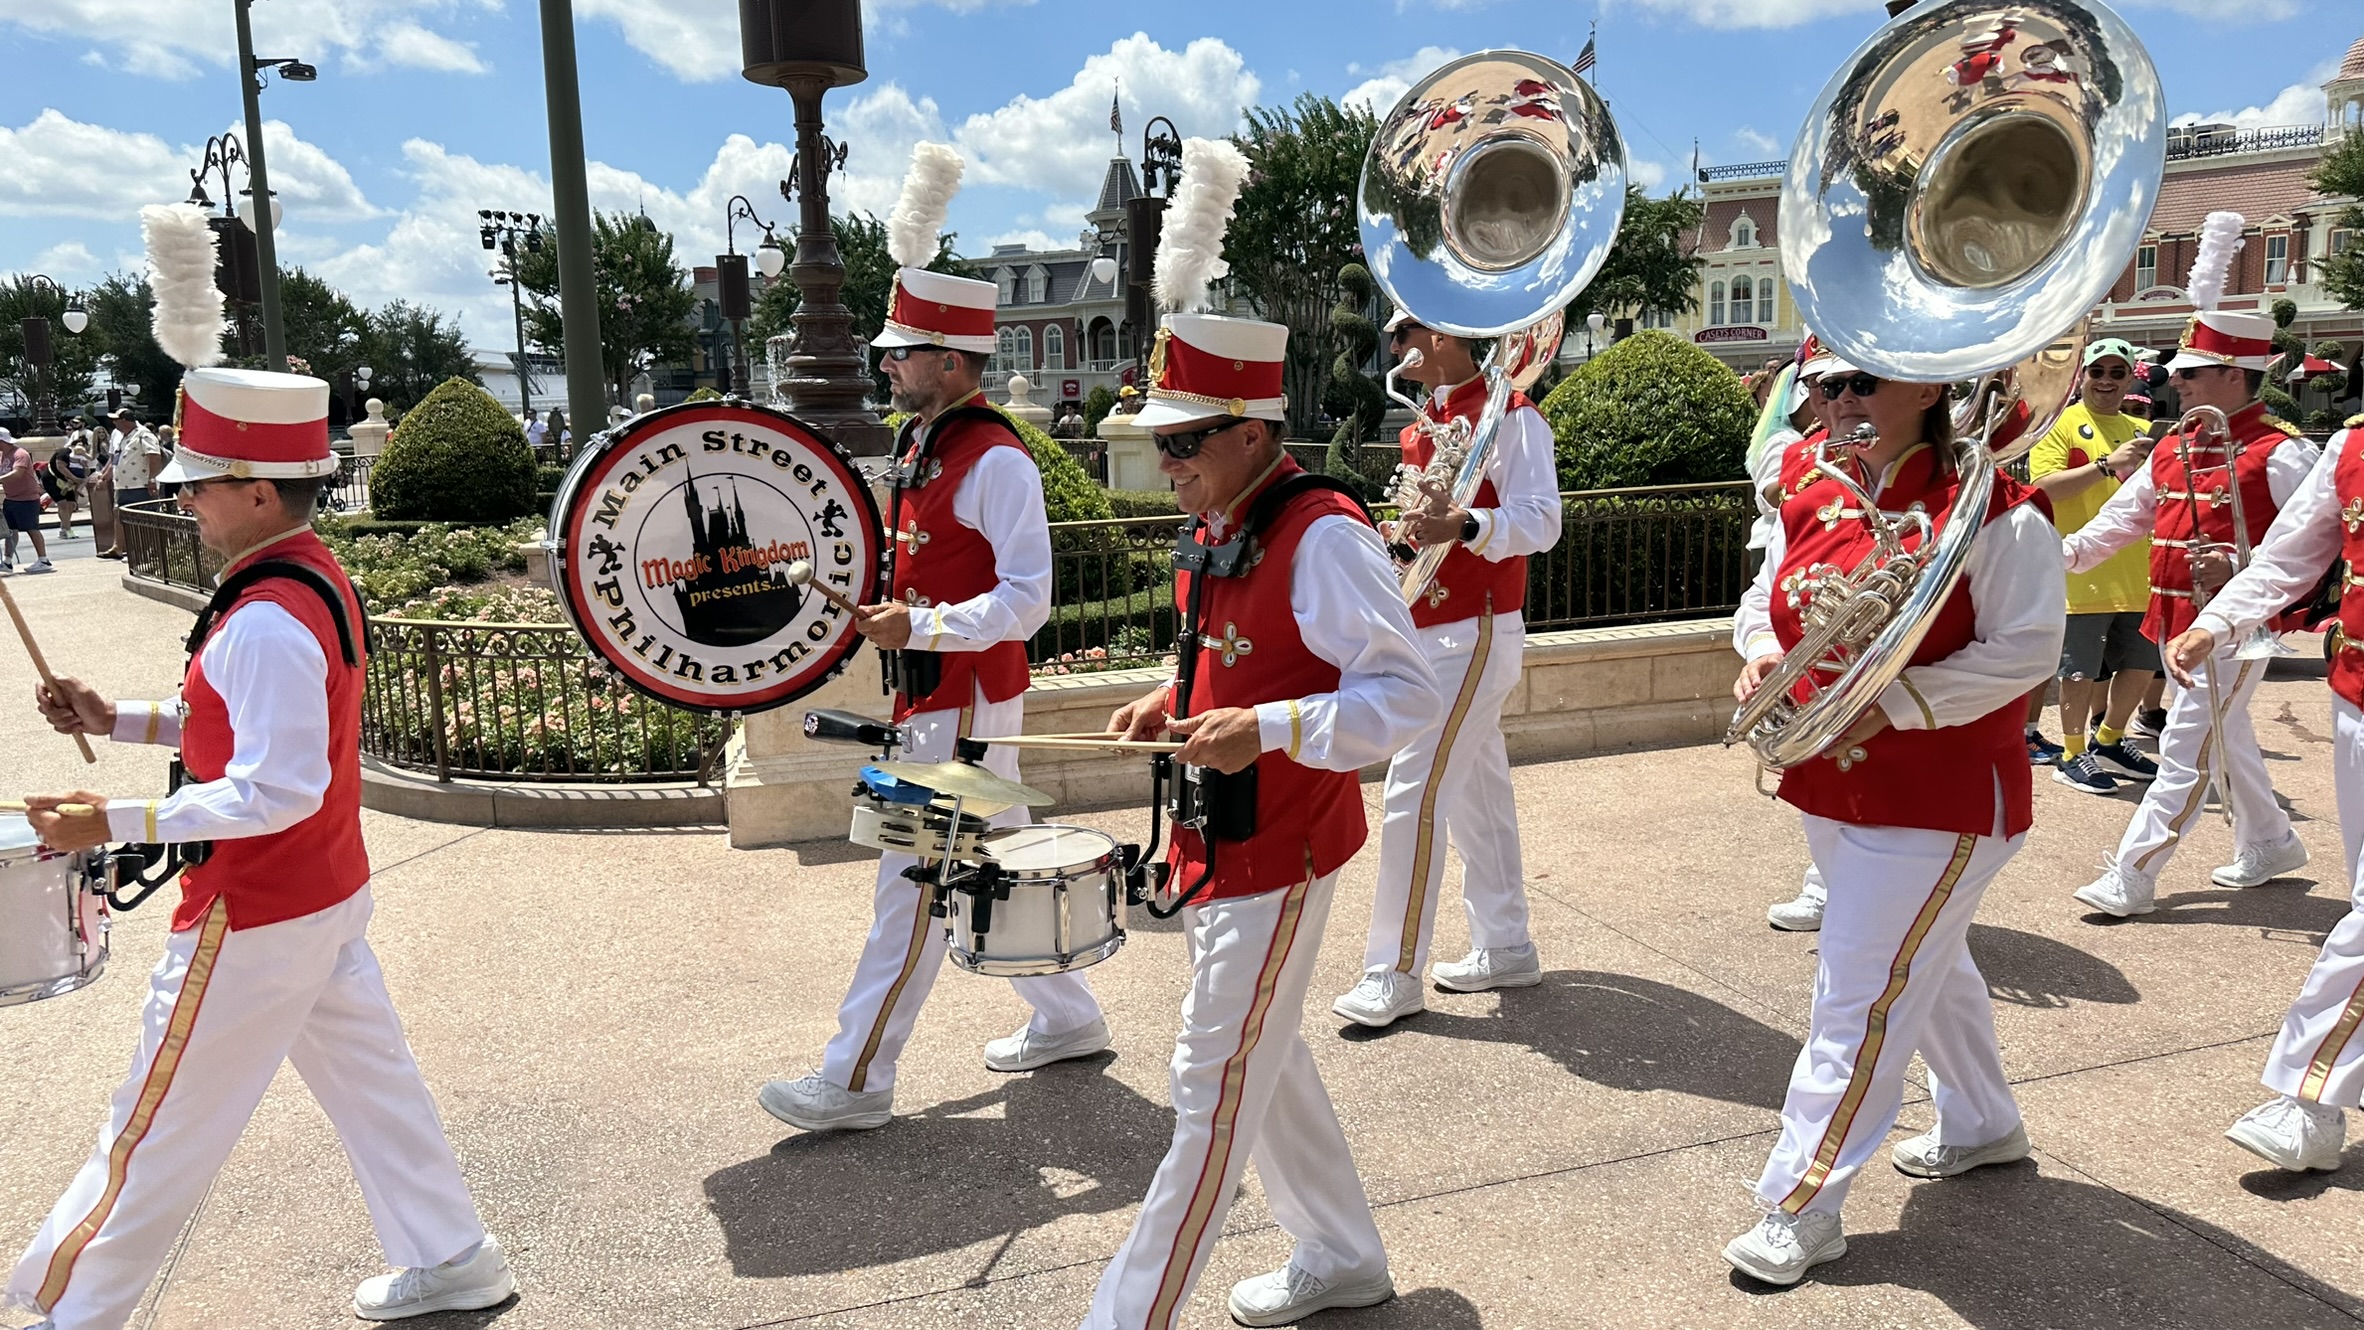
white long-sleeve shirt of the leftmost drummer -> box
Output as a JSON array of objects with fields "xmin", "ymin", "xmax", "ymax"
[{"xmin": 106, "ymin": 600, "xmax": 329, "ymax": 841}]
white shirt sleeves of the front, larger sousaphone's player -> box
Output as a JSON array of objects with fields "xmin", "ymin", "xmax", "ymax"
[{"xmin": 1733, "ymin": 465, "xmax": 2069, "ymax": 730}]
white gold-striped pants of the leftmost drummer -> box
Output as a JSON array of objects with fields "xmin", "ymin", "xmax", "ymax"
[{"xmin": 7, "ymin": 886, "xmax": 485, "ymax": 1330}]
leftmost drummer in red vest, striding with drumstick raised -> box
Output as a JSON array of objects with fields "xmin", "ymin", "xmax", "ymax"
[{"xmin": 7, "ymin": 359, "xmax": 515, "ymax": 1330}]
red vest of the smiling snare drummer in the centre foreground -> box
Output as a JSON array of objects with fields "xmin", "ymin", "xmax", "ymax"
[{"xmin": 1168, "ymin": 461, "xmax": 1369, "ymax": 900}]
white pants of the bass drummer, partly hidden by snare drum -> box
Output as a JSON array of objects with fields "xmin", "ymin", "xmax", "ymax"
[{"xmin": 820, "ymin": 692, "xmax": 1099, "ymax": 1091}]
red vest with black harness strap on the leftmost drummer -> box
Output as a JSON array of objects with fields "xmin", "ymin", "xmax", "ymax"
[{"xmin": 173, "ymin": 532, "xmax": 369, "ymax": 931}]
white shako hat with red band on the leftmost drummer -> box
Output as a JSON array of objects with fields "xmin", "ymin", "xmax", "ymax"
[{"xmin": 156, "ymin": 369, "xmax": 338, "ymax": 484}]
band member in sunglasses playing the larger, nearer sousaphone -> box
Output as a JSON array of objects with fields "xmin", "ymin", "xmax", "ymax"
[{"xmin": 1723, "ymin": 366, "xmax": 2064, "ymax": 1285}]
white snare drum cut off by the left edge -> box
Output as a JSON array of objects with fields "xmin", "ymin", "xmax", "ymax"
[{"xmin": 0, "ymin": 817, "xmax": 106, "ymax": 1006}]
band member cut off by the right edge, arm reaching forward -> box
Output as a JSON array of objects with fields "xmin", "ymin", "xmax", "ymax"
[{"xmin": 2168, "ymin": 420, "xmax": 2364, "ymax": 1172}]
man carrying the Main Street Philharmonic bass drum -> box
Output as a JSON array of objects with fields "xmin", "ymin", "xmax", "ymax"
[{"xmin": 756, "ymin": 144, "xmax": 1109, "ymax": 1132}]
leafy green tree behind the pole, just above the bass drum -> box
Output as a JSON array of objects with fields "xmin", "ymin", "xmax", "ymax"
[{"xmin": 518, "ymin": 213, "xmax": 697, "ymax": 402}]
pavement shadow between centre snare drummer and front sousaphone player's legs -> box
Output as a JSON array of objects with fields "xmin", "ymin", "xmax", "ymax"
[{"xmin": 1340, "ymin": 971, "xmax": 1799, "ymax": 1110}]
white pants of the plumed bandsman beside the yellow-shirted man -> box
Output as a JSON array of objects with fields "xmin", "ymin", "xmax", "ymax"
[{"xmin": 2118, "ymin": 647, "xmax": 2291, "ymax": 881}]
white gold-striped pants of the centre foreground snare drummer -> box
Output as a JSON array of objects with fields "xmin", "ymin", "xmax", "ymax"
[{"xmin": 1083, "ymin": 874, "xmax": 1388, "ymax": 1330}]
